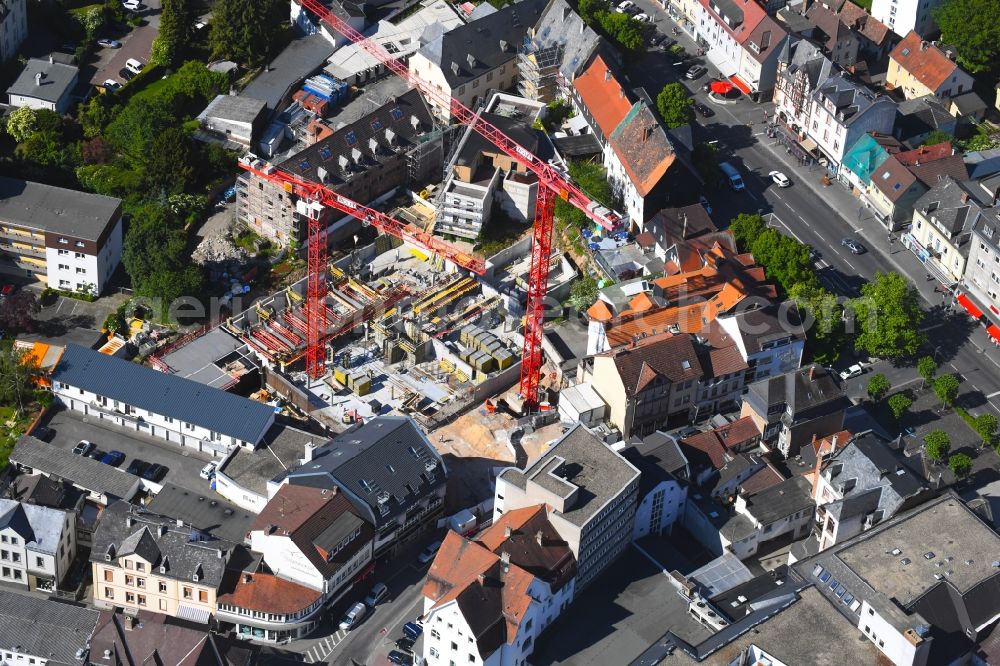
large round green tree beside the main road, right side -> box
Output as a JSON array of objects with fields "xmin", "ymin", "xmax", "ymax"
[{"xmin": 851, "ymin": 273, "xmax": 925, "ymax": 358}]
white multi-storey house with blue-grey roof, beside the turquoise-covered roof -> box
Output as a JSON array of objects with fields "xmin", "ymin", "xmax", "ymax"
[{"xmin": 807, "ymin": 73, "xmax": 896, "ymax": 173}]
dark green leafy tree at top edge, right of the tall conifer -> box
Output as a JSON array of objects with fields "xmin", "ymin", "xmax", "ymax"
[{"xmin": 208, "ymin": 0, "xmax": 288, "ymax": 65}]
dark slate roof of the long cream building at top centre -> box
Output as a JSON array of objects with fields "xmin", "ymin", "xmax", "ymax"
[{"xmin": 419, "ymin": 0, "xmax": 546, "ymax": 88}]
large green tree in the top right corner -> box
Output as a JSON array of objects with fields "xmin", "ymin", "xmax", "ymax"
[{"xmin": 933, "ymin": 0, "xmax": 1000, "ymax": 74}]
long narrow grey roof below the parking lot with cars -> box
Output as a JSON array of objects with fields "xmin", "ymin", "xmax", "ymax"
[{"xmin": 10, "ymin": 435, "xmax": 139, "ymax": 500}]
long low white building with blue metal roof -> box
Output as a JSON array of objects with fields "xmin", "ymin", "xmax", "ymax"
[{"xmin": 52, "ymin": 344, "xmax": 274, "ymax": 457}]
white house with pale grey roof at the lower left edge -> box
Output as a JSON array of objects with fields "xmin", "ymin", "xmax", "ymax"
[{"xmin": 0, "ymin": 499, "xmax": 76, "ymax": 592}]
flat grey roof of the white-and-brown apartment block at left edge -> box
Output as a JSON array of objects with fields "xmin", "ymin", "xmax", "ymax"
[{"xmin": 0, "ymin": 177, "xmax": 122, "ymax": 241}]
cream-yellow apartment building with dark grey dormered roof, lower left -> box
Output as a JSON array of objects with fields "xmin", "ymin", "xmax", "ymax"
[{"xmin": 90, "ymin": 502, "xmax": 238, "ymax": 624}]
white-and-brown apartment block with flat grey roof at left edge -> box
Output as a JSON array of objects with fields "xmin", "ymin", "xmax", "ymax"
[{"xmin": 0, "ymin": 177, "xmax": 122, "ymax": 294}]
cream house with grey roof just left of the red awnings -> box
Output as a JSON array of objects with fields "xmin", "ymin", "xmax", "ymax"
[{"xmin": 908, "ymin": 176, "xmax": 998, "ymax": 282}]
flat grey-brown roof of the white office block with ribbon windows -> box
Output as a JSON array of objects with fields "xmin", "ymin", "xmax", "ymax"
[{"xmin": 502, "ymin": 425, "xmax": 640, "ymax": 526}]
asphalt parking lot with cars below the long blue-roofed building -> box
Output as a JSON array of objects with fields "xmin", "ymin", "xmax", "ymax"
[{"xmin": 42, "ymin": 410, "xmax": 208, "ymax": 493}]
